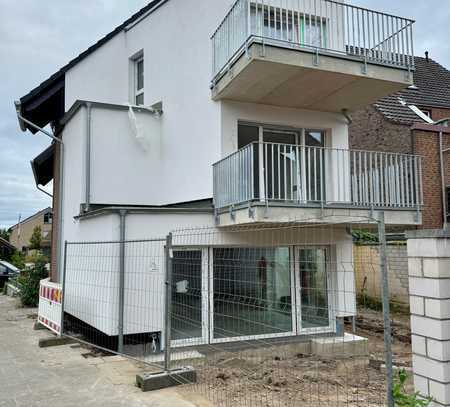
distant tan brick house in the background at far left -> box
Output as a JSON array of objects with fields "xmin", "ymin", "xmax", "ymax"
[{"xmin": 9, "ymin": 208, "xmax": 52, "ymax": 254}]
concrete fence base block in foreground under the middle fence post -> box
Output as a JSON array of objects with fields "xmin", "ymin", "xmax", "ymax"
[{"xmin": 136, "ymin": 366, "xmax": 197, "ymax": 392}]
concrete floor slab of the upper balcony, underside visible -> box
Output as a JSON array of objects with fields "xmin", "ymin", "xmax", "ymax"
[{"xmin": 212, "ymin": 42, "xmax": 412, "ymax": 112}]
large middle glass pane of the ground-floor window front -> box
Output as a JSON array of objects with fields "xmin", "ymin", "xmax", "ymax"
[{"xmin": 211, "ymin": 247, "xmax": 295, "ymax": 342}]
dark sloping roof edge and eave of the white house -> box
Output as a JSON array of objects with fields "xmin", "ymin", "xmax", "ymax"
[{"xmin": 20, "ymin": 0, "xmax": 168, "ymax": 133}]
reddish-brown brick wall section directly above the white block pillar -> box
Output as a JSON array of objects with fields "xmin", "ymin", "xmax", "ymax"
[{"xmin": 413, "ymin": 130, "xmax": 443, "ymax": 229}]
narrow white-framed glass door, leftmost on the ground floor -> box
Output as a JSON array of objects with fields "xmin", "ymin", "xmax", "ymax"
[{"xmin": 171, "ymin": 249, "xmax": 208, "ymax": 345}]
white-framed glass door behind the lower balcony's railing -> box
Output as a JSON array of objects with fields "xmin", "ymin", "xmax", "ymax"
[{"xmin": 238, "ymin": 124, "xmax": 327, "ymax": 203}]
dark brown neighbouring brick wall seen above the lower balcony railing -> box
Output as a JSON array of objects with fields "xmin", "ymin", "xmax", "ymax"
[{"xmin": 349, "ymin": 106, "xmax": 412, "ymax": 153}]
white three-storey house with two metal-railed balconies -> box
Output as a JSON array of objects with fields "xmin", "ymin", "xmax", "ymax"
[{"xmin": 16, "ymin": 0, "xmax": 422, "ymax": 350}]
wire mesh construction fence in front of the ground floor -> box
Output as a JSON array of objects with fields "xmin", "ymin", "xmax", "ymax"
[{"xmin": 62, "ymin": 215, "xmax": 407, "ymax": 407}]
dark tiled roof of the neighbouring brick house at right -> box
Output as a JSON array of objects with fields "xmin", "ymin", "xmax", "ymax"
[{"xmin": 374, "ymin": 57, "xmax": 450, "ymax": 125}]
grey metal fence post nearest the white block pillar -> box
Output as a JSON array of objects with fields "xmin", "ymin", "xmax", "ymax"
[{"xmin": 378, "ymin": 211, "xmax": 394, "ymax": 407}]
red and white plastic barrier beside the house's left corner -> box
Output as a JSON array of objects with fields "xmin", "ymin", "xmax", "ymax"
[{"xmin": 38, "ymin": 278, "xmax": 63, "ymax": 334}]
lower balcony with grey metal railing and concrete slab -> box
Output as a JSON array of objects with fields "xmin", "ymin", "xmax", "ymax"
[{"xmin": 214, "ymin": 143, "xmax": 423, "ymax": 226}]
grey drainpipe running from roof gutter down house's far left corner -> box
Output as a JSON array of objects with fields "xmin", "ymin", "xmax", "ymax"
[{"xmin": 14, "ymin": 102, "xmax": 64, "ymax": 280}]
